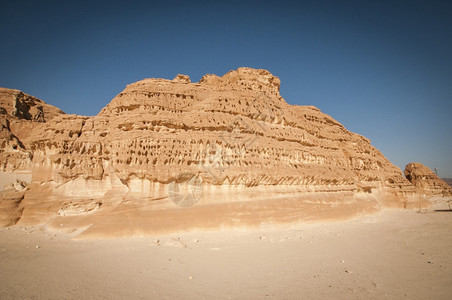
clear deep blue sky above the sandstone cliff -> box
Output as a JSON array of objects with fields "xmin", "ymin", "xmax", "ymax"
[{"xmin": 0, "ymin": 0, "xmax": 452, "ymax": 177}]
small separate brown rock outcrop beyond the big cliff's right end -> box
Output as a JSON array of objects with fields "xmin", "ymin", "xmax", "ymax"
[{"xmin": 405, "ymin": 163, "xmax": 452, "ymax": 196}]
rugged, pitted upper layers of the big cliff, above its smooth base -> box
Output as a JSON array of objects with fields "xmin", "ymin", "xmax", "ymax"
[{"xmin": 31, "ymin": 68, "xmax": 411, "ymax": 190}]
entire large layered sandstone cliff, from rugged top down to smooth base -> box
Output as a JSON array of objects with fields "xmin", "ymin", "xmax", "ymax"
[{"xmin": 1, "ymin": 68, "xmax": 444, "ymax": 235}]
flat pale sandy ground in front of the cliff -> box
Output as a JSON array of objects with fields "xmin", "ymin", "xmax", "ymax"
[{"xmin": 0, "ymin": 210, "xmax": 452, "ymax": 299}]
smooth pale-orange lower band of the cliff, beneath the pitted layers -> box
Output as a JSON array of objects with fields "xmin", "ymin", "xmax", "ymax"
[{"xmin": 0, "ymin": 179, "xmax": 438, "ymax": 238}]
